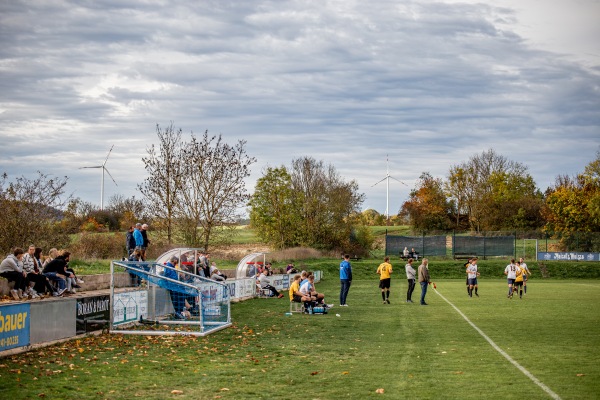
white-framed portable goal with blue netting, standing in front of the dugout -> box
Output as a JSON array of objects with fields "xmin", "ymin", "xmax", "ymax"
[{"xmin": 110, "ymin": 261, "xmax": 231, "ymax": 336}]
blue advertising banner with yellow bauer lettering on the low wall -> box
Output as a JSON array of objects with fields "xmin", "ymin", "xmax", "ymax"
[{"xmin": 0, "ymin": 303, "xmax": 31, "ymax": 351}]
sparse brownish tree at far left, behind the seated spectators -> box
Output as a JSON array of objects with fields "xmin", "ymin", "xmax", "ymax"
[{"xmin": 0, "ymin": 171, "xmax": 69, "ymax": 254}]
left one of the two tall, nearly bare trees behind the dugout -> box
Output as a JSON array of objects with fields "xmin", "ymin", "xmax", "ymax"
[{"xmin": 138, "ymin": 122, "xmax": 183, "ymax": 244}]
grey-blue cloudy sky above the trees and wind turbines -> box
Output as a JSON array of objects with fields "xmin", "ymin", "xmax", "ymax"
[{"xmin": 0, "ymin": 0, "xmax": 600, "ymax": 213}]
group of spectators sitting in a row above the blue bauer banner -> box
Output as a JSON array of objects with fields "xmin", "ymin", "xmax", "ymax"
[{"xmin": 0, "ymin": 245, "xmax": 83, "ymax": 300}]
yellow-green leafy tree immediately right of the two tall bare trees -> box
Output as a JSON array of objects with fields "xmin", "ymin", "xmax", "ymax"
[{"xmin": 249, "ymin": 166, "xmax": 299, "ymax": 249}]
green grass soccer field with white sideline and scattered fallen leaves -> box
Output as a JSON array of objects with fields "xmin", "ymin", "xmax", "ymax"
[{"xmin": 0, "ymin": 278, "xmax": 600, "ymax": 399}]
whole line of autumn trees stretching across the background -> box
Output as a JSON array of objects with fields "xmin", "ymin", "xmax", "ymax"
[{"xmin": 0, "ymin": 123, "xmax": 600, "ymax": 254}]
